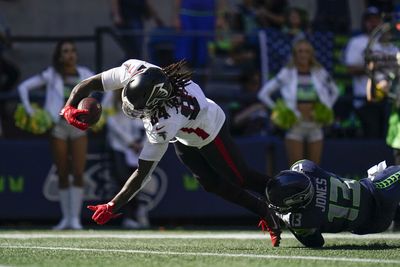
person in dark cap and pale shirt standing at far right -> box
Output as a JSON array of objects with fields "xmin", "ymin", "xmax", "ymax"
[{"xmin": 345, "ymin": 7, "xmax": 386, "ymax": 138}]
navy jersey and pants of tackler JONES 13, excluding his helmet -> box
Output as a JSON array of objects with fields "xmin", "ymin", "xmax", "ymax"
[{"xmin": 277, "ymin": 160, "xmax": 400, "ymax": 246}]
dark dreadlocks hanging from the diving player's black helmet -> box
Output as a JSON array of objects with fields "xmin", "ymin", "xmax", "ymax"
[{"xmin": 156, "ymin": 60, "xmax": 193, "ymax": 112}]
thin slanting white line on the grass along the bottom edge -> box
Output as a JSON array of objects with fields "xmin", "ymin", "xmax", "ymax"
[{"xmin": 0, "ymin": 245, "xmax": 400, "ymax": 265}]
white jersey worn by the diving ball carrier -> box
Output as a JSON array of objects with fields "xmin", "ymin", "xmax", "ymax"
[{"xmin": 102, "ymin": 60, "xmax": 225, "ymax": 161}]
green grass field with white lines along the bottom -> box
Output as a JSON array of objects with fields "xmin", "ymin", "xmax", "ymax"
[{"xmin": 0, "ymin": 230, "xmax": 400, "ymax": 267}]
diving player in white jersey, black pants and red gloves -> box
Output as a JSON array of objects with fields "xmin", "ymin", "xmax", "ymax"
[{"xmin": 61, "ymin": 59, "xmax": 281, "ymax": 246}]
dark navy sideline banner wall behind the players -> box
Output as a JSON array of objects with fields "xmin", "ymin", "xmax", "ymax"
[{"xmin": 0, "ymin": 137, "xmax": 392, "ymax": 220}]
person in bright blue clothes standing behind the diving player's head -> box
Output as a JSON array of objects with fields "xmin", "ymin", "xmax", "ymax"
[{"xmin": 174, "ymin": 0, "xmax": 226, "ymax": 68}]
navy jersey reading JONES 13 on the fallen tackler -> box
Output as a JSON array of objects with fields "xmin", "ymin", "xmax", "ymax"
[{"xmin": 278, "ymin": 160, "xmax": 373, "ymax": 246}]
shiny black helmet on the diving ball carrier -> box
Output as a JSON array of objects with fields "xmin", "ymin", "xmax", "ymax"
[{"xmin": 121, "ymin": 67, "xmax": 172, "ymax": 118}]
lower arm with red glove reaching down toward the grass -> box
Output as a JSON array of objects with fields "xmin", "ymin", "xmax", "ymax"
[{"xmin": 88, "ymin": 159, "xmax": 158, "ymax": 224}]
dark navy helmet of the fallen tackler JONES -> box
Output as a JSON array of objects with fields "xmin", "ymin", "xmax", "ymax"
[{"xmin": 266, "ymin": 171, "xmax": 314, "ymax": 214}]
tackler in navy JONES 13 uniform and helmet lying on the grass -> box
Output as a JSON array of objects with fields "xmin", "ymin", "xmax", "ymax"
[{"xmin": 266, "ymin": 160, "xmax": 400, "ymax": 247}]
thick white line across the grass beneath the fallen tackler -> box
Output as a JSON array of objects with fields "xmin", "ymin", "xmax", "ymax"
[{"xmin": 0, "ymin": 231, "xmax": 400, "ymax": 240}]
